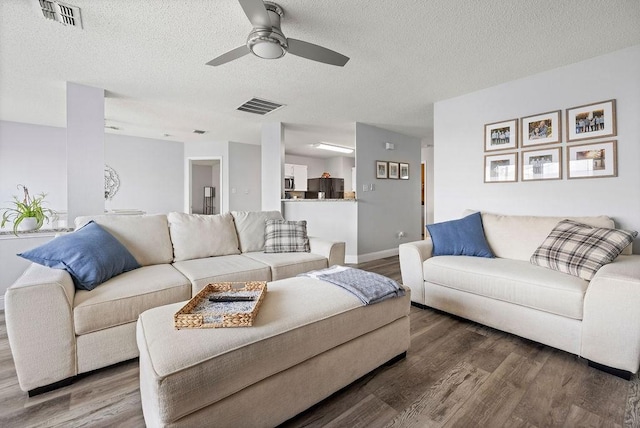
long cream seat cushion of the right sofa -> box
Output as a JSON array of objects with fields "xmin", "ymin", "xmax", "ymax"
[{"xmin": 423, "ymin": 256, "xmax": 589, "ymax": 320}]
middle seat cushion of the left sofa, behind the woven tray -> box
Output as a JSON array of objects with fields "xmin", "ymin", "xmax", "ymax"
[{"xmin": 173, "ymin": 255, "xmax": 271, "ymax": 295}]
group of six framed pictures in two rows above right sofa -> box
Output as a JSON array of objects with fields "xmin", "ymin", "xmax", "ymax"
[{"xmin": 483, "ymin": 99, "xmax": 618, "ymax": 183}]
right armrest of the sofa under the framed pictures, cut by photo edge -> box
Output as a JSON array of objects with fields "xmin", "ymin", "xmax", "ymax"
[{"xmin": 581, "ymin": 255, "xmax": 640, "ymax": 373}]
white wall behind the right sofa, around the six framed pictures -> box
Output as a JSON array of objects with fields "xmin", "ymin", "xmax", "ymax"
[{"xmin": 434, "ymin": 45, "xmax": 640, "ymax": 252}]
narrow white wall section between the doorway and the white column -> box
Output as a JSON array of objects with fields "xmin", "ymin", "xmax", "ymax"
[{"xmin": 229, "ymin": 143, "xmax": 262, "ymax": 211}]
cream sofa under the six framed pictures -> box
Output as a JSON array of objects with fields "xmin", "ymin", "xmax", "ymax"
[{"xmin": 399, "ymin": 213, "xmax": 640, "ymax": 379}]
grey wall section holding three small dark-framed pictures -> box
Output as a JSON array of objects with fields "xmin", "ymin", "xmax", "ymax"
[{"xmin": 356, "ymin": 123, "xmax": 422, "ymax": 262}]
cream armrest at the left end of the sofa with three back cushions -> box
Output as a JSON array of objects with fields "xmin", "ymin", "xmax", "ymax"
[{"xmin": 5, "ymin": 264, "xmax": 77, "ymax": 391}]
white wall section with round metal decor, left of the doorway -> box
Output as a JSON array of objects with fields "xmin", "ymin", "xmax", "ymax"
[{"xmin": 104, "ymin": 134, "xmax": 184, "ymax": 214}]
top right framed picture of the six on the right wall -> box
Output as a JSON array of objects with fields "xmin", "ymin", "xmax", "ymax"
[{"xmin": 566, "ymin": 100, "xmax": 616, "ymax": 142}]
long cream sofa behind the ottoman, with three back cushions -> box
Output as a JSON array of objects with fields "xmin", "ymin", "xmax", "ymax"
[{"xmin": 5, "ymin": 211, "xmax": 344, "ymax": 395}]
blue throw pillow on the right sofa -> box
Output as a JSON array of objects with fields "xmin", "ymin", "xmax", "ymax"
[{"xmin": 427, "ymin": 212, "xmax": 494, "ymax": 258}]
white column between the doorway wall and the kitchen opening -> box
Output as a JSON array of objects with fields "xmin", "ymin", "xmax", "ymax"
[{"xmin": 261, "ymin": 122, "xmax": 284, "ymax": 211}]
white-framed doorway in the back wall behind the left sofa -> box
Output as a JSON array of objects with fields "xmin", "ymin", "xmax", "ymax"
[{"xmin": 185, "ymin": 157, "xmax": 226, "ymax": 214}]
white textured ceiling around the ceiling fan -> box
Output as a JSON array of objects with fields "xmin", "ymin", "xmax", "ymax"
[{"xmin": 0, "ymin": 0, "xmax": 640, "ymax": 155}]
